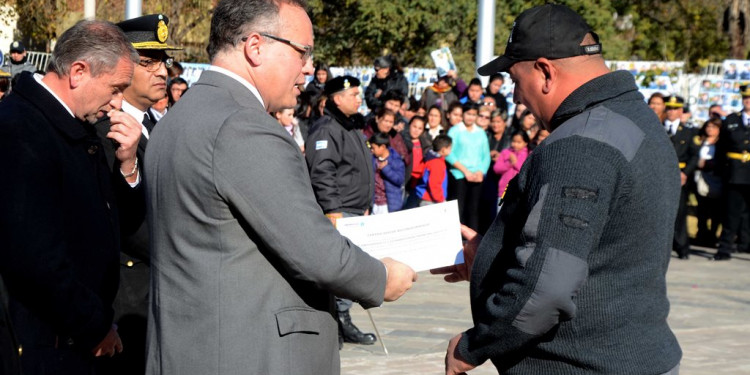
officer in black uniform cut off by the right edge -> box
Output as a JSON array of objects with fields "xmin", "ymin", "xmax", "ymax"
[{"xmin": 714, "ymin": 86, "xmax": 750, "ymax": 260}]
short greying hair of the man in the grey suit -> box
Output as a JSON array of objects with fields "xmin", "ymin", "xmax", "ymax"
[{"xmin": 206, "ymin": 0, "xmax": 307, "ymax": 60}]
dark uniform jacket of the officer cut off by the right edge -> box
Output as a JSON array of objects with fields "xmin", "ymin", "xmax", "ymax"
[{"xmin": 716, "ymin": 113, "xmax": 750, "ymax": 185}]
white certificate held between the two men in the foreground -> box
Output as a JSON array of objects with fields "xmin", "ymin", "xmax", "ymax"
[{"xmin": 336, "ymin": 201, "xmax": 464, "ymax": 272}]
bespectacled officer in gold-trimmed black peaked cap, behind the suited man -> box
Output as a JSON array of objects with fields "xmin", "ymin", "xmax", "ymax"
[{"xmin": 95, "ymin": 14, "xmax": 181, "ymax": 374}]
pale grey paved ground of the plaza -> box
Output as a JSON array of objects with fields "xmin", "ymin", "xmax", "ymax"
[{"xmin": 341, "ymin": 249, "xmax": 750, "ymax": 375}]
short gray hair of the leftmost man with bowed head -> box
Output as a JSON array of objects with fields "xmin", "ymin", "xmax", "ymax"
[{"xmin": 47, "ymin": 20, "xmax": 140, "ymax": 77}]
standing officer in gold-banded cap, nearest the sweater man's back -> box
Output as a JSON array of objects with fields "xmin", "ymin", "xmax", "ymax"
[{"xmin": 664, "ymin": 96, "xmax": 701, "ymax": 259}]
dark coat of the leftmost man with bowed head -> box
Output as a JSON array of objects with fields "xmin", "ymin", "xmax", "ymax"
[{"xmin": 0, "ymin": 73, "xmax": 145, "ymax": 374}]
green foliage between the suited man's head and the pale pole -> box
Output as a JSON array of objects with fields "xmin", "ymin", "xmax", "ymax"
[{"xmin": 309, "ymin": 0, "xmax": 477, "ymax": 78}]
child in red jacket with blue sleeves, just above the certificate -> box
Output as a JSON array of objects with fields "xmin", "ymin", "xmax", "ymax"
[{"xmin": 415, "ymin": 134, "xmax": 453, "ymax": 206}]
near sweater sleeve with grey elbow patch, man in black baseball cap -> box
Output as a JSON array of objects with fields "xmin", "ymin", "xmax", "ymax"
[{"xmin": 458, "ymin": 137, "xmax": 627, "ymax": 365}]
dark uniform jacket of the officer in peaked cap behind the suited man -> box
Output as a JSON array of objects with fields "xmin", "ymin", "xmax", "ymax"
[{"xmin": 94, "ymin": 111, "xmax": 151, "ymax": 321}]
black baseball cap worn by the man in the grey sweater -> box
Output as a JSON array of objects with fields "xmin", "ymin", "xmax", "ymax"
[{"xmin": 477, "ymin": 4, "xmax": 602, "ymax": 76}]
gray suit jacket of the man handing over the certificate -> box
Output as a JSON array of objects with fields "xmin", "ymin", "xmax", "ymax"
[{"xmin": 146, "ymin": 71, "xmax": 386, "ymax": 375}]
